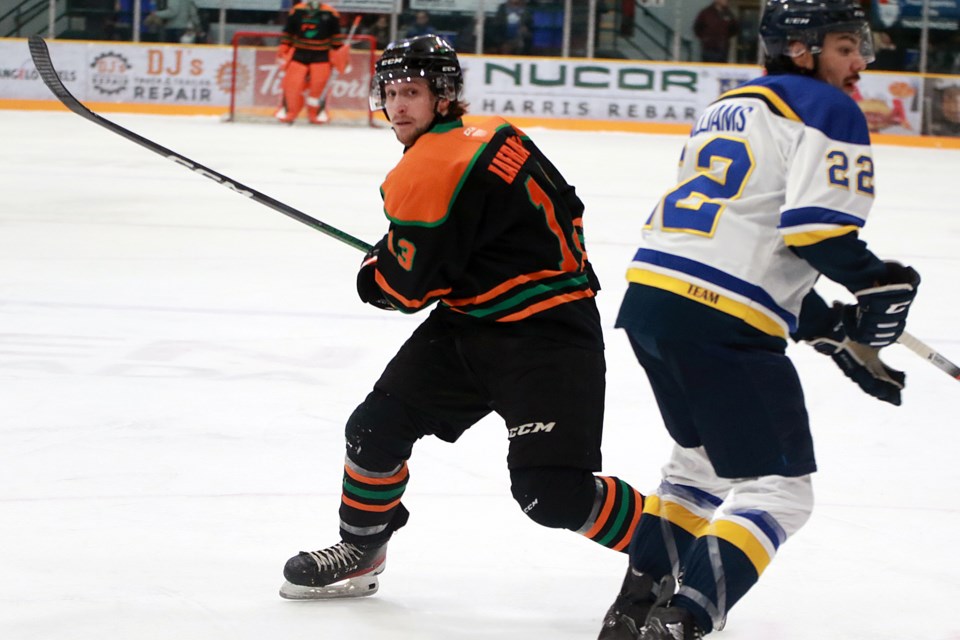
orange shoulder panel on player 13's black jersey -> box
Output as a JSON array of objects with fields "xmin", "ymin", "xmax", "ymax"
[{"xmin": 381, "ymin": 117, "xmax": 510, "ymax": 227}]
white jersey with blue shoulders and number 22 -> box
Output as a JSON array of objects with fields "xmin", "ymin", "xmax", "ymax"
[{"xmin": 627, "ymin": 75, "xmax": 874, "ymax": 338}]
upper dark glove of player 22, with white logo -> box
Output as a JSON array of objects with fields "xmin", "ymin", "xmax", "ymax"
[{"xmin": 843, "ymin": 262, "xmax": 920, "ymax": 348}]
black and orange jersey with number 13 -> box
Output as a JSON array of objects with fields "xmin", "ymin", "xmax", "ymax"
[{"xmin": 376, "ymin": 117, "xmax": 602, "ymax": 345}]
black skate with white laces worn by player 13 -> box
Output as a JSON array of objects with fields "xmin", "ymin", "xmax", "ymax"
[{"xmin": 280, "ymin": 542, "xmax": 387, "ymax": 600}]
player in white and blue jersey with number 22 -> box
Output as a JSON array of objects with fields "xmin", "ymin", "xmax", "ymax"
[{"xmin": 600, "ymin": 0, "xmax": 920, "ymax": 640}]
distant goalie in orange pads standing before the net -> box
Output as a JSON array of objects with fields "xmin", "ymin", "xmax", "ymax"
[{"xmin": 275, "ymin": 0, "xmax": 347, "ymax": 124}]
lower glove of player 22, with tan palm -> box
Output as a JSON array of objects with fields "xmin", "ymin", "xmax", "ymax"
[{"xmin": 808, "ymin": 302, "xmax": 906, "ymax": 406}]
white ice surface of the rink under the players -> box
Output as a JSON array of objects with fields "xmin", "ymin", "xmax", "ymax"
[{"xmin": 0, "ymin": 111, "xmax": 960, "ymax": 640}]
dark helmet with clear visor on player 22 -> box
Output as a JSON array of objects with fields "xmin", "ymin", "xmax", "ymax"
[{"xmin": 760, "ymin": 0, "xmax": 874, "ymax": 64}]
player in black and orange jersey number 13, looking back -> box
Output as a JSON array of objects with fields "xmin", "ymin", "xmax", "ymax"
[{"xmin": 280, "ymin": 35, "xmax": 643, "ymax": 599}]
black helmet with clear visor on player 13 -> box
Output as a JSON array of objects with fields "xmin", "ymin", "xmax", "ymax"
[{"xmin": 370, "ymin": 35, "xmax": 463, "ymax": 111}]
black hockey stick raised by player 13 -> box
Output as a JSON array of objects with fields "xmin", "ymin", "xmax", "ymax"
[{"xmin": 29, "ymin": 36, "xmax": 372, "ymax": 253}]
